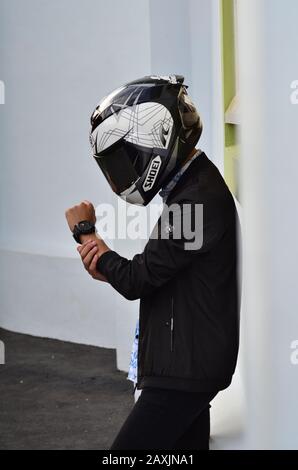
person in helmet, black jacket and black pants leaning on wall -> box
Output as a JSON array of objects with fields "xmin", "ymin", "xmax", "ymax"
[{"xmin": 66, "ymin": 75, "xmax": 239, "ymax": 449}]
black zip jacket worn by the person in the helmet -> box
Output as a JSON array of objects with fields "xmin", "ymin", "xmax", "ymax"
[{"xmin": 97, "ymin": 153, "xmax": 239, "ymax": 391}]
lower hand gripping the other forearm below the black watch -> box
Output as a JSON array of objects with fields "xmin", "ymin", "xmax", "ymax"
[{"xmin": 77, "ymin": 238, "xmax": 110, "ymax": 282}]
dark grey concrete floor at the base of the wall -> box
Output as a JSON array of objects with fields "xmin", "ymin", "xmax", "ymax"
[{"xmin": 0, "ymin": 329, "xmax": 134, "ymax": 449}]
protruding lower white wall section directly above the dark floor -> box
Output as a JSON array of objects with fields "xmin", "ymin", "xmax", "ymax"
[{"xmin": 0, "ymin": 250, "xmax": 116, "ymax": 348}]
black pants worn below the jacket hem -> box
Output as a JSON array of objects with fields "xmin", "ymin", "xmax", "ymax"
[{"xmin": 110, "ymin": 388, "xmax": 217, "ymax": 450}]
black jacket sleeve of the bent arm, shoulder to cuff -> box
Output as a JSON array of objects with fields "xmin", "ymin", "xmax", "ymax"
[{"xmin": 97, "ymin": 200, "xmax": 229, "ymax": 300}]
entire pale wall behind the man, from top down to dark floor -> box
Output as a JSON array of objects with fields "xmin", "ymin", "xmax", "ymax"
[{"xmin": 0, "ymin": 0, "xmax": 219, "ymax": 370}]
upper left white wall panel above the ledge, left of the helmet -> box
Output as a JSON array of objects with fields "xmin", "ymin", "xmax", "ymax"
[{"xmin": 0, "ymin": 0, "xmax": 150, "ymax": 255}]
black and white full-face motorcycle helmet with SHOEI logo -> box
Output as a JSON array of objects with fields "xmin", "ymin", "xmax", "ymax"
[{"xmin": 90, "ymin": 75, "xmax": 202, "ymax": 206}]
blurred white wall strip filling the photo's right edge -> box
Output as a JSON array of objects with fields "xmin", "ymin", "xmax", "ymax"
[{"xmin": 239, "ymin": 0, "xmax": 298, "ymax": 449}]
